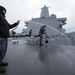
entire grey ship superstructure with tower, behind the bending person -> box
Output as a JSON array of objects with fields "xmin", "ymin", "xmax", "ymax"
[{"xmin": 23, "ymin": 5, "xmax": 71, "ymax": 45}]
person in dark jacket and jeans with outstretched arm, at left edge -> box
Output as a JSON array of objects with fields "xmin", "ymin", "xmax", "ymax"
[{"xmin": 0, "ymin": 6, "xmax": 20, "ymax": 74}]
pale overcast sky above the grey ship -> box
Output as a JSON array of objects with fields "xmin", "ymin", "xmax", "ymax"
[{"xmin": 0, "ymin": 0, "xmax": 75, "ymax": 32}]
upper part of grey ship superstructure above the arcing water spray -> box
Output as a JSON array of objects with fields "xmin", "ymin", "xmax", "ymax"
[{"xmin": 25, "ymin": 5, "xmax": 67, "ymax": 33}]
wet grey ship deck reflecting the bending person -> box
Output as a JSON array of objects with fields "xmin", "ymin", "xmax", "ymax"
[{"xmin": 2, "ymin": 39, "xmax": 75, "ymax": 75}]
